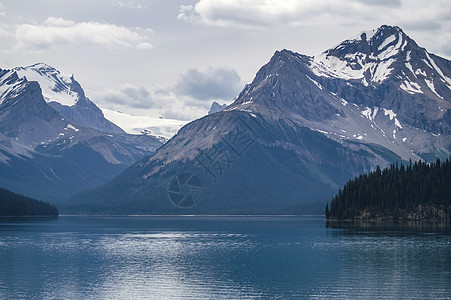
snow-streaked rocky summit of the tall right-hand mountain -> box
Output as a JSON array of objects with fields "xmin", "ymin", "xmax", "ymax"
[{"xmin": 310, "ymin": 25, "xmax": 451, "ymax": 99}]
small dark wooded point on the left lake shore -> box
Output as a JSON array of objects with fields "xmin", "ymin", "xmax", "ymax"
[{"xmin": 0, "ymin": 188, "xmax": 58, "ymax": 217}]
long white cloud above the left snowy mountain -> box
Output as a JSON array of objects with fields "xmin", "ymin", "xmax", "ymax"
[{"xmin": 15, "ymin": 17, "xmax": 152, "ymax": 50}]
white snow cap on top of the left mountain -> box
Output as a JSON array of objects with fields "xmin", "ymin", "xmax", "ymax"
[{"xmin": 13, "ymin": 63, "xmax": 85, "ymax": 106}]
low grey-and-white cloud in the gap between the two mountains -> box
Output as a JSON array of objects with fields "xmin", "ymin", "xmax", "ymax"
[{"xmin": 94, "ymin": 67, "xmax": 243, "ymax": 121}]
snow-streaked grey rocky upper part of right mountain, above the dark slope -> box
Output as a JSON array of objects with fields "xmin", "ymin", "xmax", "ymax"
[{"xmin": 231, "ymin": 26, "xmax": 451, "ymax": 160}]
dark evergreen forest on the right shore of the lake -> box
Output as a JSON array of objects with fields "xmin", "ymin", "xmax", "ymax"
[{"xmin": 325, "ymin": 159, "xmax": 451, "ymax": 220}]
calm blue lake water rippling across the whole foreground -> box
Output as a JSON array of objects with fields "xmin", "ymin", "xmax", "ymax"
[{"xmin": 0, "ymin": 217, "xmax": 451, "ymax": 299}]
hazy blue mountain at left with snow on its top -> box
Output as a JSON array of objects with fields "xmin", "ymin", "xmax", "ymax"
[{"xmin": 0, "ymin": 64, "xmax": 162, "ymax": 202}]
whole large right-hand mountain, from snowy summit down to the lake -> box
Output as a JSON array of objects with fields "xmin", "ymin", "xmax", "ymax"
[{"xmin": 64, "ymin": 26, "xmax": 451, "ymax": 214}]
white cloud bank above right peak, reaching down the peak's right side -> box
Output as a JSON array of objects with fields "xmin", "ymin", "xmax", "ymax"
[{"xmin": 177, "ymin": 0, "xmax": 451, "ymax": 55}]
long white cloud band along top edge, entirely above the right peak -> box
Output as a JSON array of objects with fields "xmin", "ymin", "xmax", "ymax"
[{"xmin": 178, "ymin": 0, "xmax": 451, "ymax": 28}]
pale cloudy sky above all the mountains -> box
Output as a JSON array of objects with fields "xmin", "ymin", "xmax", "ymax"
[{"xmin": 0, "ymin": 0, "xmax": 451, "ymax": 120}]
